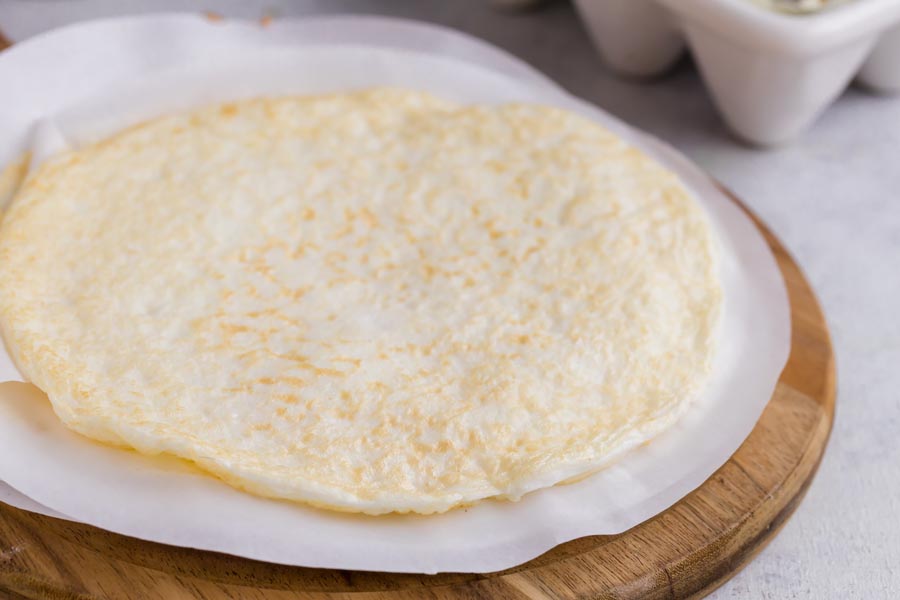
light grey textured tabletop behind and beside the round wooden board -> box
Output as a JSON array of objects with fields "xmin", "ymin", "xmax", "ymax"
[{"xmin": 0, "ymin": 0, "xmax": 900, "ymax": 599}]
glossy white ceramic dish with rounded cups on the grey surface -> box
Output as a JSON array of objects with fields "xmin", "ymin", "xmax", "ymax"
[{"xmin": 576, "ymin": 0, "xmax": 900, "ymax": 146}]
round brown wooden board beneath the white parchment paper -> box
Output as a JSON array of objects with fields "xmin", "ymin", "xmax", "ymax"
[{"xmin": 0, "ymin": 139, "xmax": 835, "ymax": 600}]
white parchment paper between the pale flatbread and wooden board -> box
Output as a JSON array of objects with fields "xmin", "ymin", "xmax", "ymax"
[{"xmin": 0, "ymin": 17, "xmax": 790, "ymax": 573}]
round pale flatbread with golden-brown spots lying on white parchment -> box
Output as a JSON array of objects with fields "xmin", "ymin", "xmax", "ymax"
[{"xmin": 0, "ymin": 90, "xmax": 721, "ymax": 514}]
